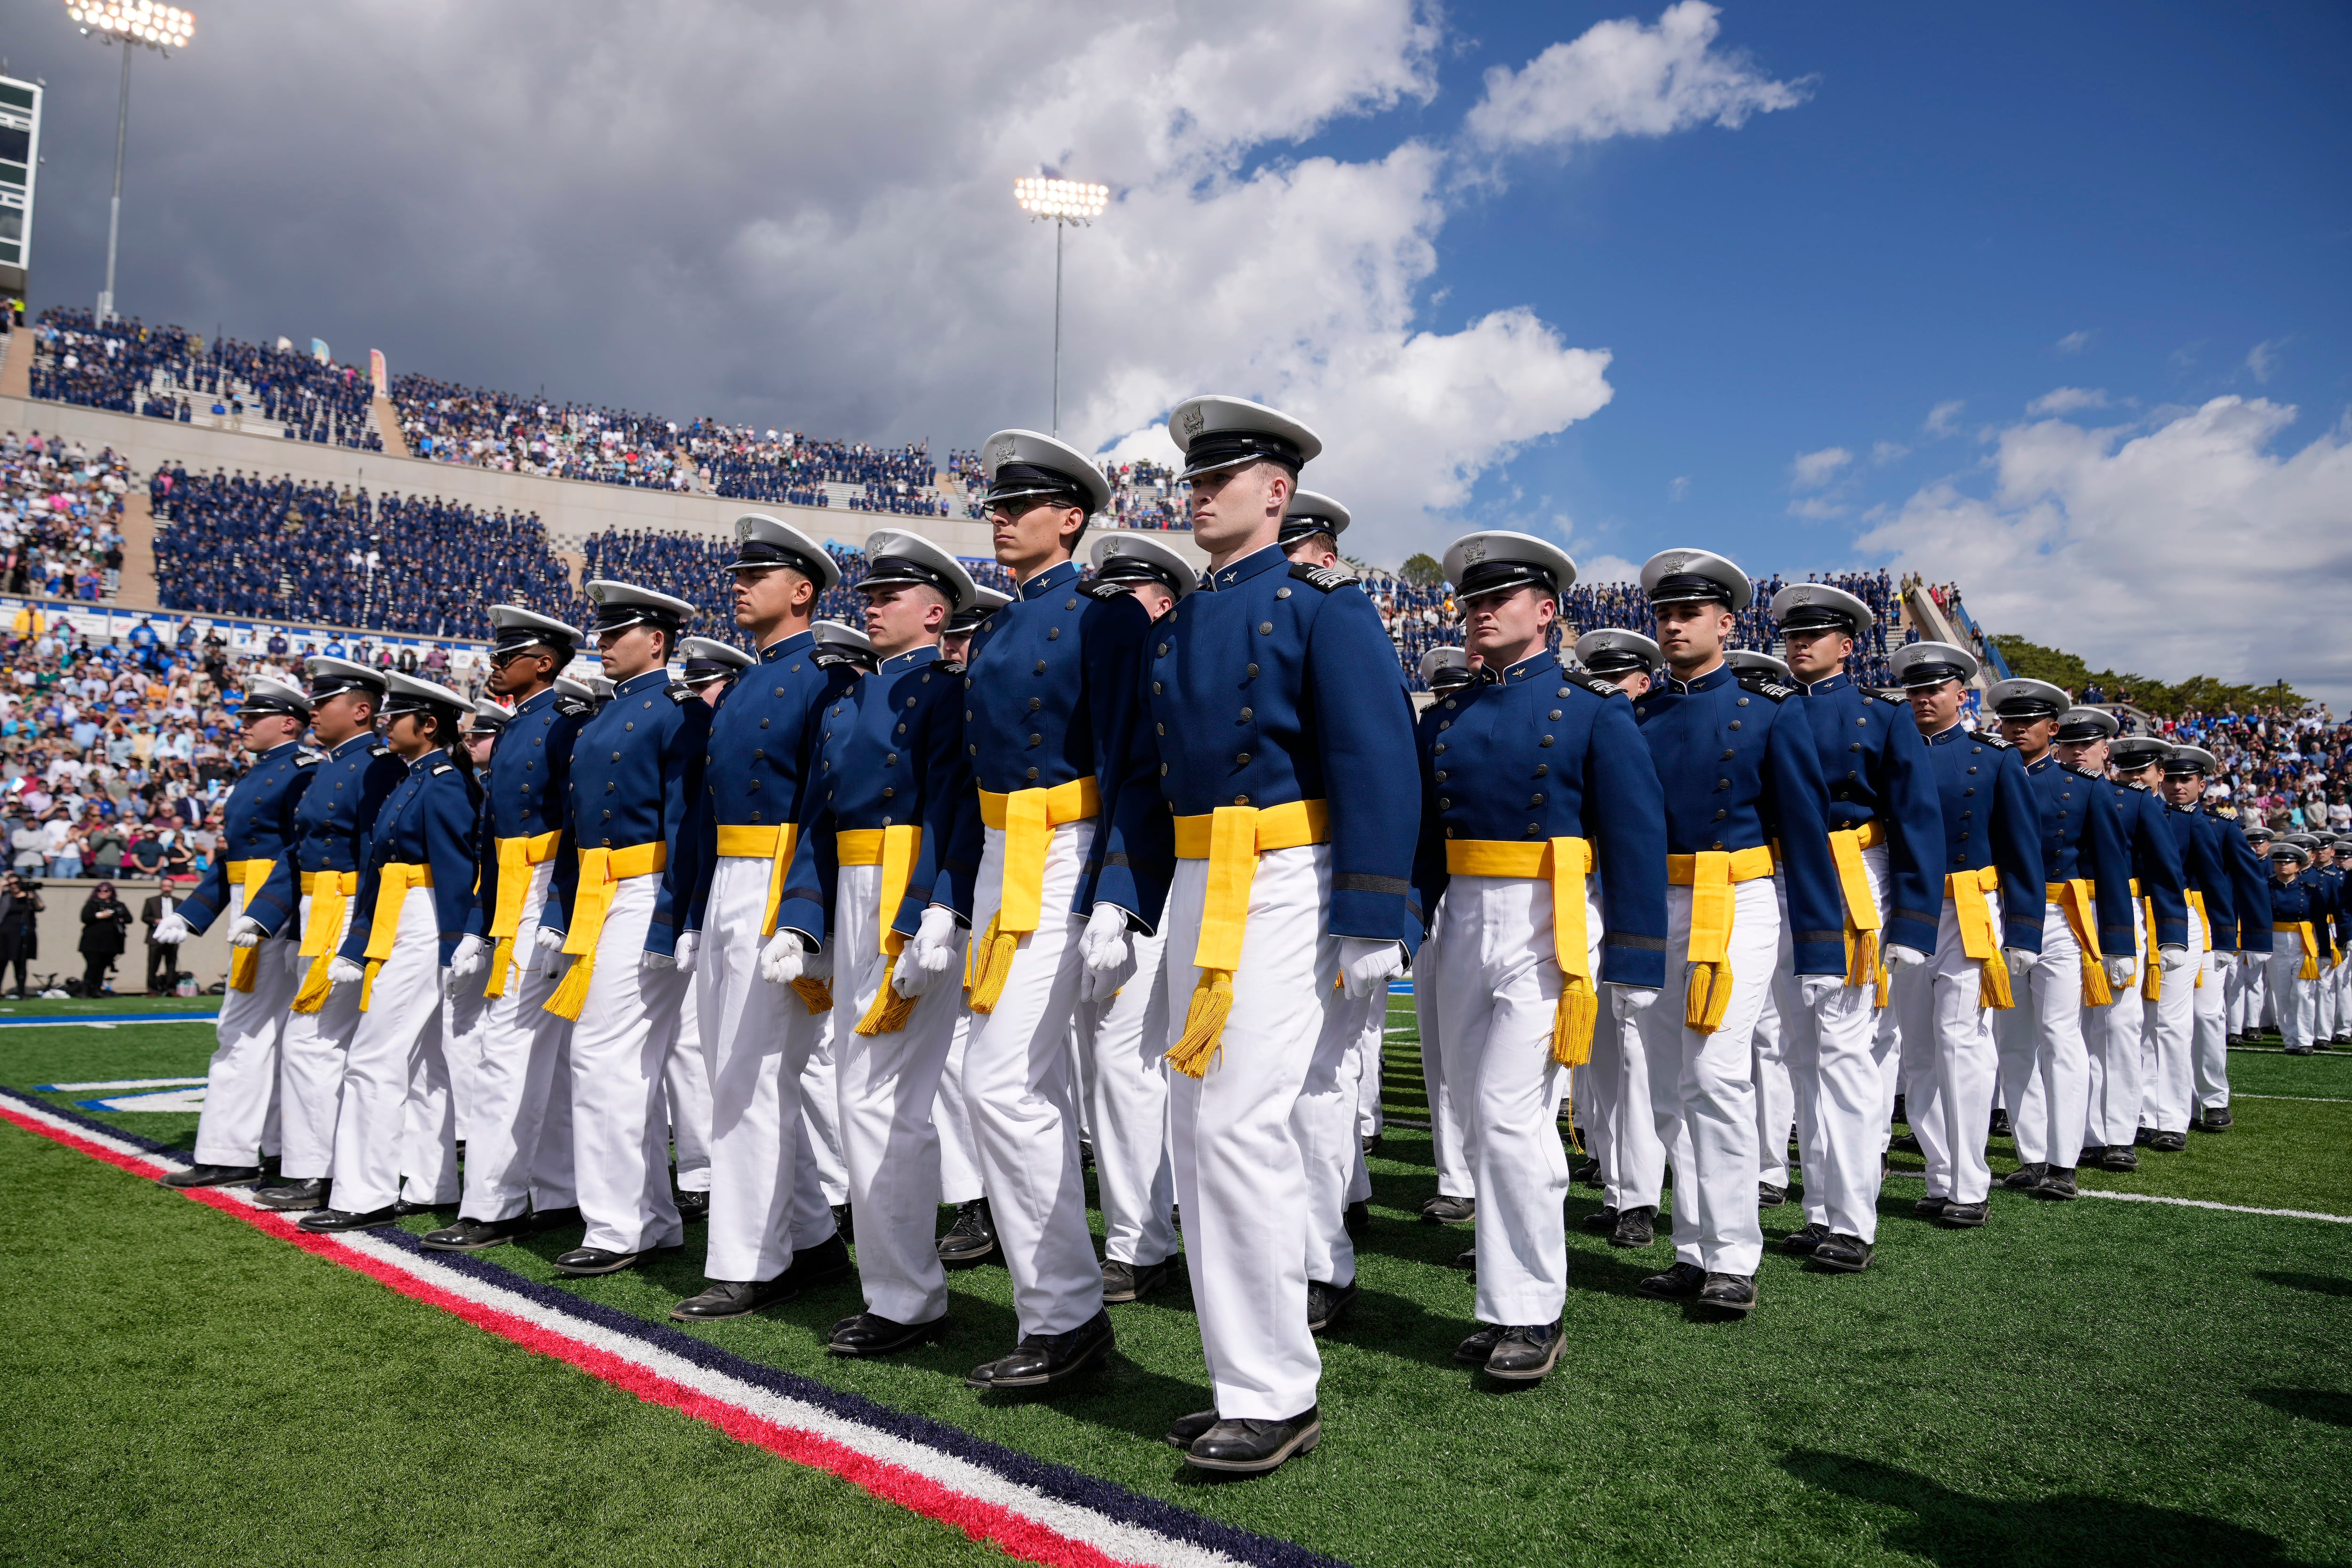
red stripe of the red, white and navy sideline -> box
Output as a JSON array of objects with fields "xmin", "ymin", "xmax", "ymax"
[{"xmin": 0, "ymin": 1105, "xmax": 1131, "ymax": 1568}]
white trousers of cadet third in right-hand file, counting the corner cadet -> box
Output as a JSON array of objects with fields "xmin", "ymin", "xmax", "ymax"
[{"xmin": 1639, "ymin": 877, "xmax": 1780, "ymax": 1276}]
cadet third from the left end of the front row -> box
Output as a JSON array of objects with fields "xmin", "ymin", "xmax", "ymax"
[{"xmin": 301, "ymin": 670, "xmax": 482, "ymax": 1232}]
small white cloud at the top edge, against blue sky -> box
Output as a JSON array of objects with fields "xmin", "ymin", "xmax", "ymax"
[{"xmin": 1463, "ymin": 0, "xmax": 1811, "ymax": 151}]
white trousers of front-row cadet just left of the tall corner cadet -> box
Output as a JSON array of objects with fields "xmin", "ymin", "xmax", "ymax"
[{"xmin": 950, "ymin": 820, "xmax": 1103, "ymax": 1335}]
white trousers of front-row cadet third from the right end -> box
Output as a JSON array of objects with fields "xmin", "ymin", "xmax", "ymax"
[{"xmin": 833, "ymin": 865, "xmax": 964, "ymax": 1323}]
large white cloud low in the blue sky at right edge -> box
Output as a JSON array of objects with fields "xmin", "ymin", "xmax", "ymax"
[{"xmin": 1856, "ymin": 397, "xmax": 2352, "ymax": 712}]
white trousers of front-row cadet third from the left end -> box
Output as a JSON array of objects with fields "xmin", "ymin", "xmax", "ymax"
[{"xmin": 334, "ymin": 889, "xmax": 456, "ymax": 1213}]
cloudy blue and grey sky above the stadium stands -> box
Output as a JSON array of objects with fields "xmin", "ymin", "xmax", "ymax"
[{"xmin": 18, "ymin": 0, "xmax": 2352, "ymax": 703}]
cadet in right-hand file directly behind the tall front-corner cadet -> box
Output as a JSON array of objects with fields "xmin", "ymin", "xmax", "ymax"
[{"xmin": 1414, "ymin": 531, "xmax": 1665, "ymax": 1382}]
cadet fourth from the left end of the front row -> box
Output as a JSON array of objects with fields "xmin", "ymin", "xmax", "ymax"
[{"xmin": 423, "ymin": 604, "xmax": 593, "ymax": 1253}]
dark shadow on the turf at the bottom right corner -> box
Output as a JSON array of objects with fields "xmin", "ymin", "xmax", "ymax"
[{"xmin": 1780, "ymin": 1448, "xmax": 2296, "ymax": 1568}]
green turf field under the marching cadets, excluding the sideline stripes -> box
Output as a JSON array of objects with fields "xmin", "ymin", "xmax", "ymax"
[{"xmin": 0, "ymin": 1004, "xmax": 2352, "ymax": 1568}]
